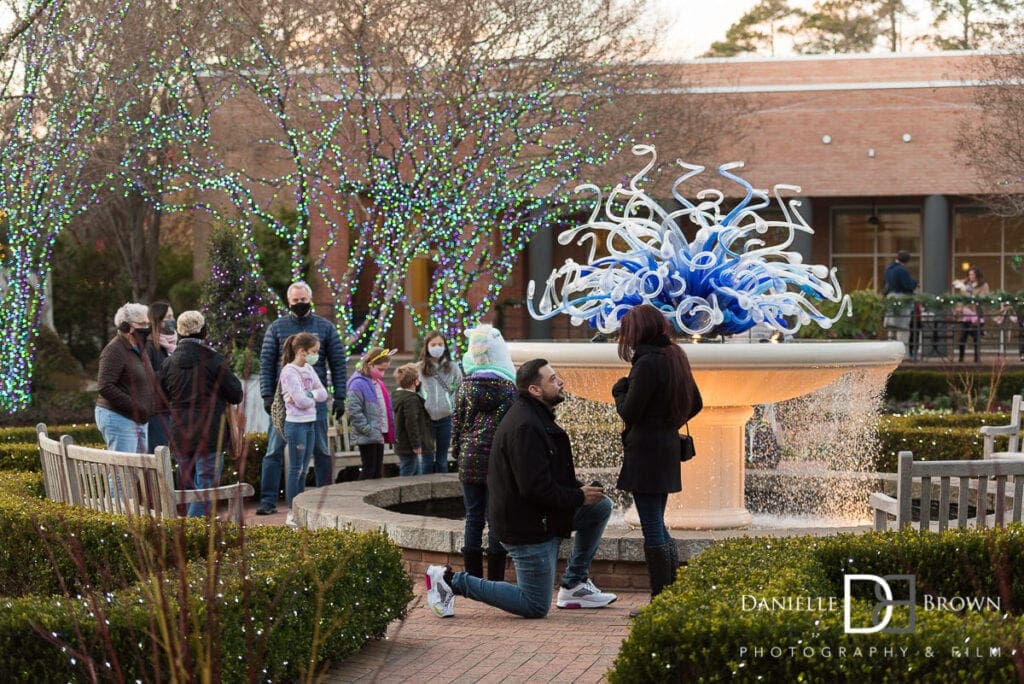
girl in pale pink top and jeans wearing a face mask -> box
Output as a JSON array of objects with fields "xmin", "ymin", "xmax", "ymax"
[{"xmin": 280, "ymin": 333, "xmax": 328, "ymax": 525}]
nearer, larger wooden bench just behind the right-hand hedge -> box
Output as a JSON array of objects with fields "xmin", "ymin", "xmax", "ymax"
[{"xmin": 868, "ymin": 452, "xmax": 1024, "ymax": 531}]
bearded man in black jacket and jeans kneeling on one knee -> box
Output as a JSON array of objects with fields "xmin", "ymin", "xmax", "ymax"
[{"xmin": 426, "ymin": 358, "xmax": 615, "ymax": 617}]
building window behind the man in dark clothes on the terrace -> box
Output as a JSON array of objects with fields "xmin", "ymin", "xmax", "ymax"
[{"xmin": 830, "ymin": 207, "xmax": 921, "ymax": 292}]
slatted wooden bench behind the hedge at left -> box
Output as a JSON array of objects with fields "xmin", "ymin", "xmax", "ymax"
[{"xmin": 52, "ymin": 438, "xmax": 255, "ymax": 523}]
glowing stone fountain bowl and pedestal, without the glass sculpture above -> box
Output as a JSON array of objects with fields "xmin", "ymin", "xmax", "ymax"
[{"xmin": 509, "ymin": 342, "xmax": 904, "ymax": 529}]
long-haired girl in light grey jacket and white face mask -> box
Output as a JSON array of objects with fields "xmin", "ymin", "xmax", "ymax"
[{"xmin": 416, "ymin": 331, "xmax": 462, "ymax": 475}]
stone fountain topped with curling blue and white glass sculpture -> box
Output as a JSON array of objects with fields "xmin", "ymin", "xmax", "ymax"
[{"xmin": 520, "ymin": 145, "xmax": 904, "ymax": 529}]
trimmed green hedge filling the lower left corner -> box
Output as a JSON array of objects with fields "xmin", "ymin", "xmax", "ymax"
[{"xmin": 0, "ymin": 473, "xmax": 412, "ymax": 682}]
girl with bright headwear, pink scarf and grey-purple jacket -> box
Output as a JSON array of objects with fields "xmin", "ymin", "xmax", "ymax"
[{"xmin": 345, "ymin": 347, "xmax": 397, "ymax": 480}]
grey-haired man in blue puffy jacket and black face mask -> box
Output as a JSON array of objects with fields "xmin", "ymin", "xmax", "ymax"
[{"xmin": 256, "ymin": 281, "xmax": 346, "ymax": 515}]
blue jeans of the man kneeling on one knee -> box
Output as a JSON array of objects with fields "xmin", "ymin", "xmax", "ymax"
[{"xmin": 452, "ymin": 497, "xmax": 612, "ymax": 617}]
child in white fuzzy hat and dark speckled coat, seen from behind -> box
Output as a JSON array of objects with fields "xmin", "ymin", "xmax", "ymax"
[{"xmin": 452, "ymin": 325, "xmax": 516, "ymax": 580}]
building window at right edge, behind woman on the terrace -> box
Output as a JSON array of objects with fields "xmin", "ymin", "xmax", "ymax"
[{"xmin": 950, "ymin": 207, "xmax": 1024, "ymax": 292}]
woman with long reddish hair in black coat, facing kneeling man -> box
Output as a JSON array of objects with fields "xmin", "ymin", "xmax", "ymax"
[{"xmin": 611, "ymin": 304, "xmax": 703, "ymax": 596}]
